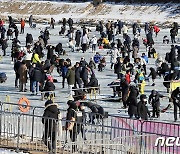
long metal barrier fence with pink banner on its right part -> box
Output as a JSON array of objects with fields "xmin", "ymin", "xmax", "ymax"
[{"xmin": 0, "ymin": 102, "xmax": 180, "ymax": 154}]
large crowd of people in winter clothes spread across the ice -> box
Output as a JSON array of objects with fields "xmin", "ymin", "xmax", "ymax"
[{"xmin": 0, "ymin": 15, "xmax": 180, "ymax": 153}]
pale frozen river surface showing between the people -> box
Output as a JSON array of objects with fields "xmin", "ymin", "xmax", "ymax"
[{"xmin": 0, "ymin": 24, "xmax": 179, "ymax": 121}]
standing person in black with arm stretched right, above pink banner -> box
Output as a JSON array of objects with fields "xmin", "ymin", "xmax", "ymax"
[{"xmin": 149, "ymin": 90, "xmax": 164, "ymax": 118}]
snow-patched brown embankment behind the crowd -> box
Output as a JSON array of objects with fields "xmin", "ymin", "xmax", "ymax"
[{"xmin": 0, "ymin": 0, "xmax": 180, "ymax": 24}]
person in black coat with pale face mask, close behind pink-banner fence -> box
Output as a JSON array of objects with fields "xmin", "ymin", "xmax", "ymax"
[{"xmin": 137, "ymin": 94, "xmax": 150, "ymax": 120}]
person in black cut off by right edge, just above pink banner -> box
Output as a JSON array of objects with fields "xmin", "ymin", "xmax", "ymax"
[{"xmin": 171, "ymin": 87, "xmax": 180, "ymax": 121}]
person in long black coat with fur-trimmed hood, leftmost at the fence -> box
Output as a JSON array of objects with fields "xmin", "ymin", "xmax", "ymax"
[{"xmin": 42, "ymin": 100, "xmax": 60, "ymax": 151}]
